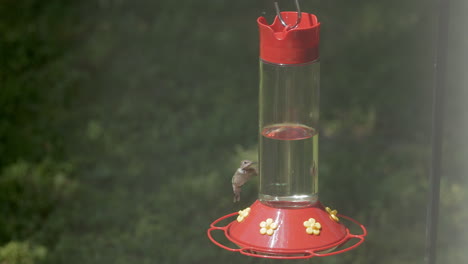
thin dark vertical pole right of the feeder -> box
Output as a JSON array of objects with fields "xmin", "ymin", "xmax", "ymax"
[{"xmin": 426, "ymin": 0, "xmax": 450, "ymax": 264}]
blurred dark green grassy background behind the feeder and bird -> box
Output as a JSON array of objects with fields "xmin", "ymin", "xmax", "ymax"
[{"xmin": 0, "ymin": 0, "xmax": 468, "ymax": 264}]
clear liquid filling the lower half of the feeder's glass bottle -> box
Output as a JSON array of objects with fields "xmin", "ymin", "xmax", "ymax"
[{"xmin": 259, "ymin": 124, "xmax": 318, "ymax": 207}]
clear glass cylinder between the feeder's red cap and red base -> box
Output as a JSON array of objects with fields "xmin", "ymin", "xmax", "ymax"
[{"xmin": 259, "ymin": 59, "xmax": 320, "ymax": 207}]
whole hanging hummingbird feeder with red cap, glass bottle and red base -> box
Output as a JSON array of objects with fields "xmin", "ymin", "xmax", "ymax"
[{"xmin": 208, "ymin": 0, "xmax": 367, "ymax": 259}]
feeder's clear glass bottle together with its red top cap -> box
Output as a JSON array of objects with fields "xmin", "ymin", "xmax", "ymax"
[{"xmin": 259, "ymin": 12, "xmax": 320, "ymax": 207}]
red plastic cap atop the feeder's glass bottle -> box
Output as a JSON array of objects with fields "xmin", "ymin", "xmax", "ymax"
[{"xmin": 257, "ymin": 12, "xmax": 320, "ymax": 64}]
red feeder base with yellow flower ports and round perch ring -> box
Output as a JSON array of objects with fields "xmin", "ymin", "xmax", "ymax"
[{"xmin": 208, "ymin": 200, "xmax": 367, "ymax": 259}]
